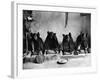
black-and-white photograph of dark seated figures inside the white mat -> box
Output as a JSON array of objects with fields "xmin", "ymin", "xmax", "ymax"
[{"xmin": 22, "ymin": 9, "xmax": 91, "ymax": 70}]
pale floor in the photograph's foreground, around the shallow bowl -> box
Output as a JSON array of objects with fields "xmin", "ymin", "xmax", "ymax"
[{"xmin": 23, "ymin": 54, "xmax": 91, "ymax": 69}]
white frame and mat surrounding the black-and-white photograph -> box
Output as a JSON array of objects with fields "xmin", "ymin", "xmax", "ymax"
[{"xmin": 11, "ymin": 2, "xmax": 97, "ymax": 78}]
